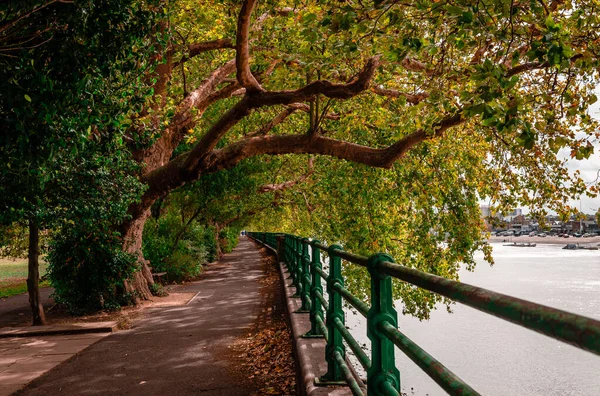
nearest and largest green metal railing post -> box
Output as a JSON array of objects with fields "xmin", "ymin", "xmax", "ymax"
[{"xmin": 367, "ymin": 253, "xmax": 400, "ymax": 396}]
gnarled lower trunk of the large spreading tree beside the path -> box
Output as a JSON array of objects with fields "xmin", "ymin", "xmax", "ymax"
[{"xmin": 122, "ymin": 207, "xmax": 154, "ymax": 302}]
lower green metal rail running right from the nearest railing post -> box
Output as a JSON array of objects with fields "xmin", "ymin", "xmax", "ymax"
[{"xmin": 381, "ymin": 322, "xmax": 479, "ymax": 396}]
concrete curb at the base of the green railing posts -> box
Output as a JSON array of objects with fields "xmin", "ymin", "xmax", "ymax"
[{"xmin": 251, "ymin": 241, "xmax": 352, "ymax": 396}]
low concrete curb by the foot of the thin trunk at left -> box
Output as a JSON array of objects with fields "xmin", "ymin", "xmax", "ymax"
[{"xmin": 0, "ymin": 322, "xmax": 117, "ymax": 338}]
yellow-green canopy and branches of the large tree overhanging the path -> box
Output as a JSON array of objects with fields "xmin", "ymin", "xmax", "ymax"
[{"xmin": 2, "ymin": 0, "xmax": 600, "ymax": 316}]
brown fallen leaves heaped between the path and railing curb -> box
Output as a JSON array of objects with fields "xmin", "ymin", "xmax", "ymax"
[{"xmin": 233, "ymin": 248, "xmax": 297, "ymax": 395}]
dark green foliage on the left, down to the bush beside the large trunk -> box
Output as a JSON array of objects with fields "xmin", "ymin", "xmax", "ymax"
[{"xmin": 0, "ymin": 0, "xmax": 156, "ymax": 313}]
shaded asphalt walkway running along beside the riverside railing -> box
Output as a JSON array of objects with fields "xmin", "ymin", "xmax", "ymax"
[{"xmin": 7, "ymin": 238, "xmax": 262, "ymax": 396}]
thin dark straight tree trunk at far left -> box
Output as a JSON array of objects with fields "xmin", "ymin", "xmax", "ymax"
[{"xmin": 27, "ymin": 220, "xmax": 46, "ymax": 326}]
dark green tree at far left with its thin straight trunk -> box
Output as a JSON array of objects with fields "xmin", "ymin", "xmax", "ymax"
[{"xmin": 0, "ymin": 0, "xmax": 158, "ymax": 325}]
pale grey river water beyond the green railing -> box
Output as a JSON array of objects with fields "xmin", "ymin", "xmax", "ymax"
[{"xmin": 347, "ymin": 244, "xmax": 600, "ymax": 396}]
